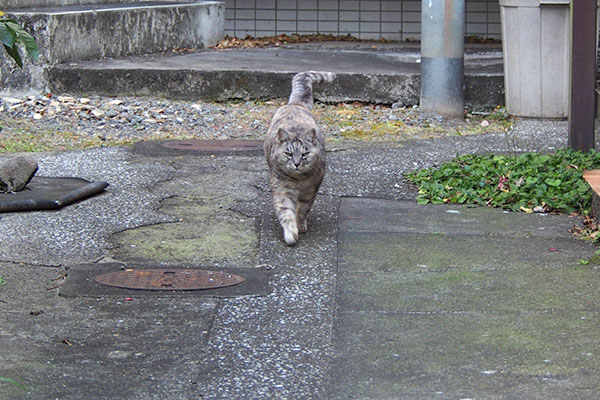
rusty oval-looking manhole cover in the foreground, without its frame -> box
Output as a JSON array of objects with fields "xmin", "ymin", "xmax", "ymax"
[{"xmin": 94, "ymin": 269, "xmax": 245, "ymax": 291}]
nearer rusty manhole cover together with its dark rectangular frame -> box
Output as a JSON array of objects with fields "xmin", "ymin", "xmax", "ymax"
[{"xmin": 60, "ymin": 263, "xmax": 270, "ymax": 297}]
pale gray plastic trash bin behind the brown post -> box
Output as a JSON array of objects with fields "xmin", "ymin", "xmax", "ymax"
[{"xmin": 500, "ymin": 0, "xmax": 600, "ymax": 118}]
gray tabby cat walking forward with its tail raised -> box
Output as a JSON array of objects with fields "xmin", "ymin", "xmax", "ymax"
[{"xmin": 264, "ymin": 71, "xmax": 335, "ymax": 246}]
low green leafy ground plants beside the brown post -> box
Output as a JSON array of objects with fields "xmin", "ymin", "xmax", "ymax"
[{"xmin": 406, "ymin": 149, "xmax": 600, "ymax": 214}]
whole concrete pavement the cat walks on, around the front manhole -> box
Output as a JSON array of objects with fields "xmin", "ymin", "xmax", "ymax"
[{"xmin": 0, "ymin": 123, "xmax": 600, "ymax": 399}]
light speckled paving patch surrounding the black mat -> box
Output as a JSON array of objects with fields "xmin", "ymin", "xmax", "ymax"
[{"xmin": 0, "ymin": 147, "xmax": 175, "ymax": 266}]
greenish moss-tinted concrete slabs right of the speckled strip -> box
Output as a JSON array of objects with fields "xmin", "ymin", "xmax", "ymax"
[{"xmin": 327, "ymin": 199, "xmax": 600, "ymax": 399}]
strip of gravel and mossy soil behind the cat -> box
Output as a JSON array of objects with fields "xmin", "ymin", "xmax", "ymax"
[{"xmin": 0, "ymin": 94, "xmax": 507, "ymax": 152}]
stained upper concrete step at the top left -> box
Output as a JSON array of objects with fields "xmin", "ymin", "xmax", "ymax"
[{"xmin": 0, "ymin": 0, "xmax": 225, "ymax": 90}]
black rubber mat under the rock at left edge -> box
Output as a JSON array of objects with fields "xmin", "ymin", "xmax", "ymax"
[{"xmin": 0, "ymin": 176, "xmax": 108, "ymax": 212}]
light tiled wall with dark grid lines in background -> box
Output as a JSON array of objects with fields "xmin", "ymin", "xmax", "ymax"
[{"xmin": 225, "ymin": 0, "xmax": 501, "ymax": 40}]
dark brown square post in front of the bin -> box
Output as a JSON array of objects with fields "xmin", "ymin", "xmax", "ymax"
[{"xmin": 569, "ymin": 0, "xmax": 597, "ymax": 151}]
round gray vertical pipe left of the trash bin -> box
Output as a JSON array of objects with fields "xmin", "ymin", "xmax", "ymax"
[{"xmin": 420, "ymin": 0, "xmax": 465, "ymax": 118}]
